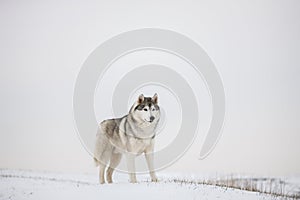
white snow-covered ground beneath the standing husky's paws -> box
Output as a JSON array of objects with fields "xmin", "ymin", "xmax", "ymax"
[{"xmin": 0, "ymin": 169, "xmax": 300, "ymax": 200}]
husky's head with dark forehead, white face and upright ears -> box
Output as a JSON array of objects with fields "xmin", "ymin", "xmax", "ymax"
[{"xmin": 132, "ymin": 93, "xmax": 160, "ymax": 124}]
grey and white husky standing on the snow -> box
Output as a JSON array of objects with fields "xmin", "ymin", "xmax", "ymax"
[{"xmin": 94, "ymin": 94, "xmax": 160, "ymax": 184}]
